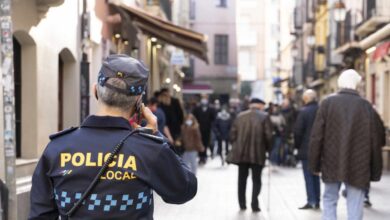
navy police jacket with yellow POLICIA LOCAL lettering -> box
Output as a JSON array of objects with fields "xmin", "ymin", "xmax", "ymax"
[{"xmin": 30, "ymin": 116, "xmax": 197, "ymax": 219}]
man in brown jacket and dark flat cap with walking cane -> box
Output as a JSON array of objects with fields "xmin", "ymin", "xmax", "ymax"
[{"xmin": 227, "ymin": 98, "xmax": 272, "ymax": 212}]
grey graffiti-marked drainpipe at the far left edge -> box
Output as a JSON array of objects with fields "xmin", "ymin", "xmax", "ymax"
[{"xmin": 0, "ymin": 0, "xmax": 17, "ymax": 219}]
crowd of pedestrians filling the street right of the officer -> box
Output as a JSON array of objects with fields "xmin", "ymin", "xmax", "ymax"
[{"xmin": 151, "ymin": 70, "xmax": 385, "ymax": 219}]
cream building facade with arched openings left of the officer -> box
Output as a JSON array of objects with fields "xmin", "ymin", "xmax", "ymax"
[{"xmin": 0, "ymin": 0, "xmax": 92, "ymax": 219}]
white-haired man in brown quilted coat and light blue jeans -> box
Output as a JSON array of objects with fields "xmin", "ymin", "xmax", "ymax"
[{"xmin": 309, "ymin": 69, "xmax": 384, "ymax": 220}]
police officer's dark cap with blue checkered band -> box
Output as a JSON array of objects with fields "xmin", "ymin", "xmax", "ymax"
[{"xmin": 98, "ymin": 54, "xmax": 149, "ymax": 96}]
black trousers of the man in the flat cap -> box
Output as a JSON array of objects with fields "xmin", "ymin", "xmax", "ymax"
[{"xmin": 238, "ymin": 164, "xmax": 263, "ymax": 209}]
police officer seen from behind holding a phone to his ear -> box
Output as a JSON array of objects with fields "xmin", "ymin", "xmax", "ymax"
[{"xmin": 29, "ymin": 55, "xmax": 197, "ymax": 220}]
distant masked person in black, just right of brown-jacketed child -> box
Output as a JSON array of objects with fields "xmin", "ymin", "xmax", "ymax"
[{"xmin": 192, "ymin": 94, "xmax": 216, "ymax": 164}]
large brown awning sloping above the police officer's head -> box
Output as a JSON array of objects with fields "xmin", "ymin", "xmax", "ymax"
[{"xmin": 110, "ymin": 4, "xmax": 208, "ymax": 63}]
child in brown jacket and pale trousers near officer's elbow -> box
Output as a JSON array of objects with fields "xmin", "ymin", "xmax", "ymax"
[{"xmin": 181, "ymin": 114, "xmax": 204, "ymax": 174}]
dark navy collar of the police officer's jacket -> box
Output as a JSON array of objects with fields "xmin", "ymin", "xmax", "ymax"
[{"xmin": 81, "ymin": 115, "xmax": 132, "ymax": 130}]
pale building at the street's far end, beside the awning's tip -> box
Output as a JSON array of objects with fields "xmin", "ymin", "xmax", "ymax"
[{"xmin": 188, "ymin": 0, "xmax": 237, "ymax": 103}]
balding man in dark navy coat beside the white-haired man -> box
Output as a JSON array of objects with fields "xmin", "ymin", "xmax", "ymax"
[{"xmin": 294, "ymin": 89, "xmax": 321, "ymax": 209}]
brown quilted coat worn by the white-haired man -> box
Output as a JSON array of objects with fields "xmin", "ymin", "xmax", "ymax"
[{"xmin": 309, "ymin": 89, "xmax": 384, "ymax": 189}]
